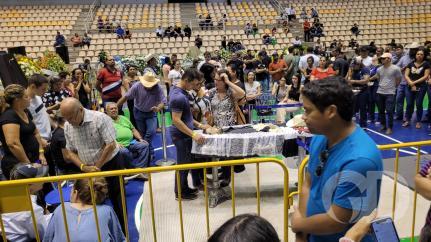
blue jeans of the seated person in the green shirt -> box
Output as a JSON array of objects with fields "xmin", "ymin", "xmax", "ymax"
[{"xmin": 120, "ymin": 140, "xmax": 149, "ymax": 168}]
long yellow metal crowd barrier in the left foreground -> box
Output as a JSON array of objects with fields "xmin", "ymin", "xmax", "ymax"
[{"xmin": 0, "ymin": 158, "xmax": 289, "ymax": 242}]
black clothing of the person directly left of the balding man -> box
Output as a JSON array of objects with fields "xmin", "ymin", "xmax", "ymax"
[{"xmin": 50, "ymin": 127, "xmax": 80, "ymax": 174}]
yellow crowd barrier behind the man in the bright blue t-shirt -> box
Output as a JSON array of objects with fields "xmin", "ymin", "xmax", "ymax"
[{"xmin": 289, "ymin": 140, "xmax": 431, "ymax": 242}]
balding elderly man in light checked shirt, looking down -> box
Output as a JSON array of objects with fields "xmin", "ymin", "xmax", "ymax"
[{"xmin": 60, "ymin": 97, "xmax": 127, "ymax": 232}]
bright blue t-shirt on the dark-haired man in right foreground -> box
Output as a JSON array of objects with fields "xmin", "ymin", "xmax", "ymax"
[{"xmin": 307, "ymin": 127, "xmax": 383, "ymax": 242}]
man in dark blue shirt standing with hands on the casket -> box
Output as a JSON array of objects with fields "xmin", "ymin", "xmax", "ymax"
[{"xmin": 169, "ymin": 68, "xmax": 209, "ymax": 200}]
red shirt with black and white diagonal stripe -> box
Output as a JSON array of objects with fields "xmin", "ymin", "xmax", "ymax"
[{"xmin": 97, "ymin": 68, "xmax": 123, "ymax": 101}]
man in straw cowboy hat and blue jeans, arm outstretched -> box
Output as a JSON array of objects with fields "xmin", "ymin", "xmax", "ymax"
[{"xmin": 117, "ymin": 72, "xmax": 166, "ymax": 161}]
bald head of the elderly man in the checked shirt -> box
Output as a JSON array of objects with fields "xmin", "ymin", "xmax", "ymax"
[{"xmin": 60, "ymin": 97, "xmax": 84, "ymax": 126}]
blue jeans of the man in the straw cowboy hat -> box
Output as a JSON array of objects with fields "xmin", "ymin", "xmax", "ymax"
[{"xmin": 133, "ymin": 108, "xmax": 157, "ymax": 157}]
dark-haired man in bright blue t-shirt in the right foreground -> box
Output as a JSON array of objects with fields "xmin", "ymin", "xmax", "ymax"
[{"xmin": 292, "ymin": 77, "xmax": 383, "ymax": 242}]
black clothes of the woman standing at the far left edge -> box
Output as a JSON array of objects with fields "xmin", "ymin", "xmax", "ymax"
[{"xmin": 0, "ymin": 108, "xmax": 39, "ymax": 179}]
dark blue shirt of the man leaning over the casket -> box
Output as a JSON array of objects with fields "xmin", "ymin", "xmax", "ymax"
[{"xmin": 169, "ymin": 86, "xmax": 194, "ymax": 139}]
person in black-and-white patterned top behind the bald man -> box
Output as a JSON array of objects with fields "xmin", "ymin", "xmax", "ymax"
[{"xmin": 42, "ymin": 77, "xmax": 71, "ymax": 113}]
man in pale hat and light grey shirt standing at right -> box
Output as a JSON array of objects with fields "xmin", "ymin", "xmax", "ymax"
[{"xmin": 370, "ymin": 53, "xmax": 402, "ymax": 134}]
